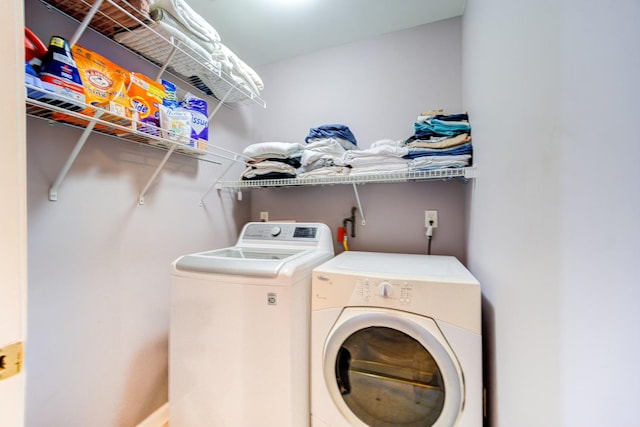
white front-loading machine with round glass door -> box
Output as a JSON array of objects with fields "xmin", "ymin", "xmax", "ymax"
[{"xmin": 311, "ymin": 252, "xmax": 483, "ymax": 427}]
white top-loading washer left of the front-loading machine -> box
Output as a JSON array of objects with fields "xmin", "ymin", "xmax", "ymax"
[{"xmin": 169, "ymin": 222, "xmax": 333, "ymax": 427}]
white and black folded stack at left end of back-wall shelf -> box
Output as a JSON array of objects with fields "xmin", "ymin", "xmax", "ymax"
[{"xmin": 240, "ymin": 142, "xmax": 304, "ymax": 180}]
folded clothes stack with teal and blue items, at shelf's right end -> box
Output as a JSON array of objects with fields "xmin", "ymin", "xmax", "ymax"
[{"xmin": 404, "ymin": 110, "xmax": 473, "ymax": 172}]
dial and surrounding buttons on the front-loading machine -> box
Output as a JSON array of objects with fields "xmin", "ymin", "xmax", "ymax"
[{"xmin": 353, "ymin": 277, "xmax": 413, "ymax": 306}]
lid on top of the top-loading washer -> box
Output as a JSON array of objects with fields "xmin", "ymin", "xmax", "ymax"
[{"xmin": 175, "ymin": 247, "xmax": 311, "ymax": 277}]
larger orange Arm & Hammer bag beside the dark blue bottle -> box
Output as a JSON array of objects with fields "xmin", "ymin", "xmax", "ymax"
[{"xmin": 53, "ymin": 45, "xmax": 132, "ymax": 134}]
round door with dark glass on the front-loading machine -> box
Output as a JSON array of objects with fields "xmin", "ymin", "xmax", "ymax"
[{"xmin": 323, "ymin": 308, "xmax": 464, "ymax": 427}]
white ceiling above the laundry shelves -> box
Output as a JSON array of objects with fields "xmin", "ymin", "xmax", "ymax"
[{"xmin": 187, "ymin": 0, "xmax": 465, "ymax": 67}]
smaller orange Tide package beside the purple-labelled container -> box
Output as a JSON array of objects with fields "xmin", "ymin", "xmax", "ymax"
[{"xmin": 127, "ymin": 73, "xmax": 165, "ymax": 136}]
